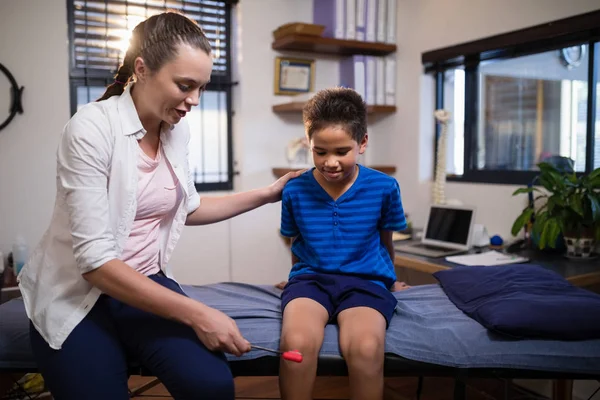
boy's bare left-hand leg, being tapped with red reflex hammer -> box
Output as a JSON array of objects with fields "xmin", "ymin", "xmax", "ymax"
[{"xmin": 279, "ymin": 298, "xmax": 329, "ymax": 400}]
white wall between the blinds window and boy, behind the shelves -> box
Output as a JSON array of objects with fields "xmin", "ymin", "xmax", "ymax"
[{"xmin": 231, "ymin": 0, "xmax": 338, "ymax": 283}]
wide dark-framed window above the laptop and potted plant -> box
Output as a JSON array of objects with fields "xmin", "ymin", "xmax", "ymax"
[{"xmin": 423, "ymin": 12, "xmax": 600, "ymax": 184}]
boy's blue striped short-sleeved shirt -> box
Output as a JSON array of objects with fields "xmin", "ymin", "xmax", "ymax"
[{"xmin": 281, "ymin": 165, "xmax": 406, "ymax": 288}]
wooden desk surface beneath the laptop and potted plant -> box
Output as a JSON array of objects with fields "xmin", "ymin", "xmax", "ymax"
[{"xmin": 394, "ymin": 244, "xmax": 600, "ymax": 288}]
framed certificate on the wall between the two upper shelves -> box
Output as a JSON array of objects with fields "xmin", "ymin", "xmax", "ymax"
[{"xmin": 274, "ymin": 57, "xmax": 315, "ymax": 95}]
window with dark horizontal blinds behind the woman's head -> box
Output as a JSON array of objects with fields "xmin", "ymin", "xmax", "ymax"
[{"xmin": 67, "ymin": 0, "xmax": 236, "ymax": 191}]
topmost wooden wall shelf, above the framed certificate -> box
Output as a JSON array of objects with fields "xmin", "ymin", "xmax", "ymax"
[{"xmin": 271, "ymin": 34, "xmax": 396, "ymax": 56}]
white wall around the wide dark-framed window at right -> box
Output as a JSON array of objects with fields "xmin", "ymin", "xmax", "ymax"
[{"xmin": 371, "ymin": 0, "xmax": 600, "ymax": 239}]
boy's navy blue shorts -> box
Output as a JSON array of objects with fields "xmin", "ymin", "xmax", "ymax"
[{"xmin": 281, "ymin": 274, "xmax": 398, "ymax": 329}]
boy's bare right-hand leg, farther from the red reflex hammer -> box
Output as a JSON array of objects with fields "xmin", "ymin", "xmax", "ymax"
[{"xmin": 338, "ymin": 307, "xmax": 386, "ymax": 400}]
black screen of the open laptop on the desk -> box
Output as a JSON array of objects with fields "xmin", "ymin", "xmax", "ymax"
[{"xmin": 425, "ymin": 206, "xmax": 473, "ymax": 245}]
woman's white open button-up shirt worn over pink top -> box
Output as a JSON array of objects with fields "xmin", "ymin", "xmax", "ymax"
[{"xmin": 19, "ymin": 85, "xmax": 200, "ymax": 349}]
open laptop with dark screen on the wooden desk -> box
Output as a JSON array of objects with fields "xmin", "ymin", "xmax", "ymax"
[{"xmin": 394, "ymin": 204, "xmax": 475, "ymax": 258}]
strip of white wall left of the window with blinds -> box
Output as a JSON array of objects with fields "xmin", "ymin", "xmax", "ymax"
[{"xmin": 0, "ymin": 0, "xmax": 69, "ymax": 266}]
